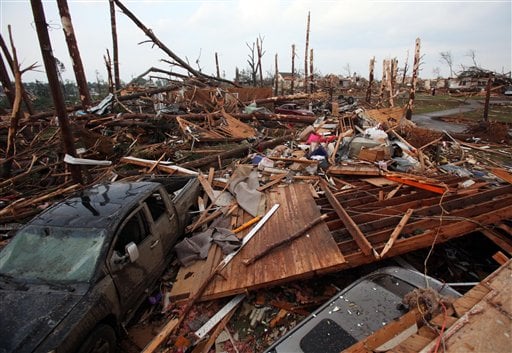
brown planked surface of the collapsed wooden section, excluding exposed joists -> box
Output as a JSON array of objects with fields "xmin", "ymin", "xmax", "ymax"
[{"xmin": 171, "ymin": 184, "xmax": 345, "ymax": 300}]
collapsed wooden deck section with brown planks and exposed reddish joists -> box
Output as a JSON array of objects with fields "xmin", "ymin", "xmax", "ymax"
[{"xmin": 171, "ymin": 175, "xmax": 512, "ymax": 300}]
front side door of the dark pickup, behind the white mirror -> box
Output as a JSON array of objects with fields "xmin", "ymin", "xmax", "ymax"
[{"xmin": 109, "ymin": 204, "xmax": 164, "ymax": 308}]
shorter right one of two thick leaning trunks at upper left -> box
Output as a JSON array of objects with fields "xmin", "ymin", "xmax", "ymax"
[{"xmin": 57, "ymin": 0, "xmax": 92, "ymax": 108}]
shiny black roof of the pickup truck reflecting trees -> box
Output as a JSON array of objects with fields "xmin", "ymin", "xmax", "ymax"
[{"xmin": 28, "ymin": 182, "xmax": 160, "ymax": 229}]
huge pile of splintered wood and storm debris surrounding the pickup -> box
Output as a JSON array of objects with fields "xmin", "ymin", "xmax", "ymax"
[{"xmin": 0, "ymin": 80, "xmax": 512, "ymax": 353}]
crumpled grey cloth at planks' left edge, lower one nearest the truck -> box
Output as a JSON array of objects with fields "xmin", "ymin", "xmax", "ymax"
[{"xmin": 175, "ymin": 227, "xmax": 242, "ymax": 267}]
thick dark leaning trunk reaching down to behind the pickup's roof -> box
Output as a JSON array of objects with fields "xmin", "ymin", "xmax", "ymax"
[{"xmin": 30, "ymin": 0, "xmax": 82, "ymax": 184}]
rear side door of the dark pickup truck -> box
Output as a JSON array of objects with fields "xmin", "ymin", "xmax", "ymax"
[{"xmin": 145, "ymin": 188, "xmax": 180, "ymax": 256}]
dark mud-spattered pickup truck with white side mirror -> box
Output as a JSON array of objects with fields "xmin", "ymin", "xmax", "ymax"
[{"xmin": 0, "ymin": 177, "xmax": 200, "ymax": 353}]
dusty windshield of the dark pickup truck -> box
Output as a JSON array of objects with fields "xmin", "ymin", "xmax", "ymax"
[{"xmin": 0, "ymin": 226, "xmax": 105, "ymax": 282}]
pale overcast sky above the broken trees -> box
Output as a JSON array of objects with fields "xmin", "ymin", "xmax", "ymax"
[{"xmin": 0, "ymin": 0, "xmax": 512, "ymax": 81}]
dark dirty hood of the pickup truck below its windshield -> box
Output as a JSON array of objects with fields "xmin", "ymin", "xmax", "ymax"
[{"xmin": 0, "ymin": 289, "xmax": 83, "ymax": 353}]
